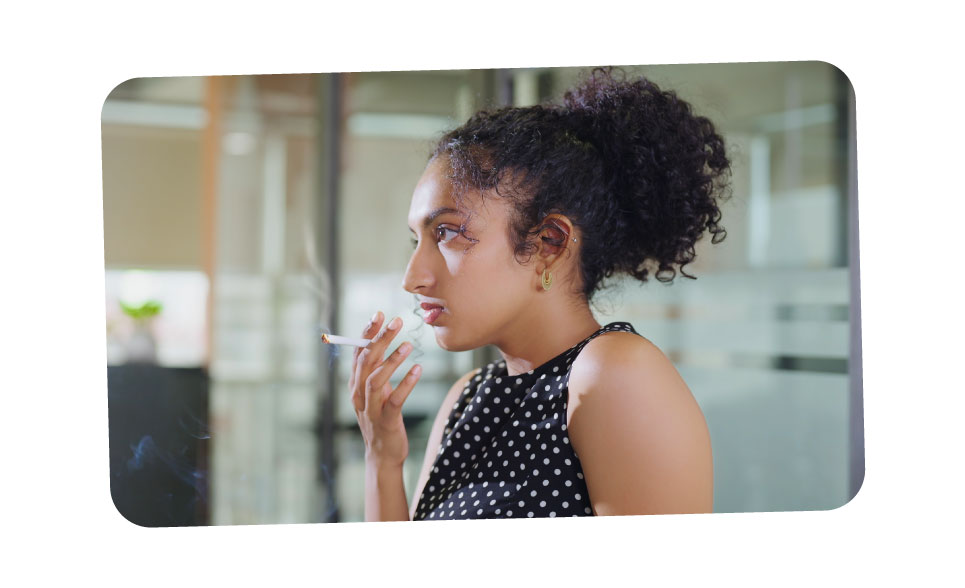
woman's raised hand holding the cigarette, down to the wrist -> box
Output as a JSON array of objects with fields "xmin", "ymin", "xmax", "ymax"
[{"xmin": 346, "ymin": 311, "xmax": 422, "ymax": 468}]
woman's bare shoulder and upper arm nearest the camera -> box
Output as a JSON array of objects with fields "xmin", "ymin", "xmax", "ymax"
[{"xmin": 567, "ymin": 333, "xmax": 713, "ymax": 515}]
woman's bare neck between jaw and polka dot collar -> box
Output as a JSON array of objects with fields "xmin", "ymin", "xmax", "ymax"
[{"xmin": 495, "ymin": 297, "xmax": 600, "ymax": 376}]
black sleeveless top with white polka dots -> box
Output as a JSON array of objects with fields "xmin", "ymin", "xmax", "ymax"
[{"xmin": 413, "ymin": 322, "xmax": 636, "ymax": 521}]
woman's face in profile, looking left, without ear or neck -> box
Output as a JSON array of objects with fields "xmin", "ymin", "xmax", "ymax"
[{"xmin": 403, "ymin": 158, "xmax": 535, "ymax": 351}]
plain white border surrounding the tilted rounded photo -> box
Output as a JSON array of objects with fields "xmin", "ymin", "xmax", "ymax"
[{"xmin": 0, "ymin": 1, "xmax": 965, "ymax": 586}]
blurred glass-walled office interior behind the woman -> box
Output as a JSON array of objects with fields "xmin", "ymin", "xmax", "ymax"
[{"xmin": 102, "ymin": 62, "xmax": 864, "ymax": 526}]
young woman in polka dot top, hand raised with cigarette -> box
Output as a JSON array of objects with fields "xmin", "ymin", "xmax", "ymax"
[{"xmin": 349, "ymin": 69, "xmax": 729, "ymax": 521}]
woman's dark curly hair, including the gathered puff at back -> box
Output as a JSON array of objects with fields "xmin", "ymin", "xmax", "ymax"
[{"xmin": 430, "ymin": 67, "xmax": 730, "ymax": 300}]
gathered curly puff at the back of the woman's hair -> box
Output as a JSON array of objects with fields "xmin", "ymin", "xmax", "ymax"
[{"xmin": 562, "ymin": 67, "xmax": 730, "ymax": 280}]
